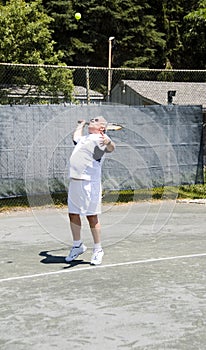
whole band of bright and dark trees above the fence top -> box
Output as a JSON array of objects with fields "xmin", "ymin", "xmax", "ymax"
[{"xmin": 0, "ymin": 0, "xmax": 206, "ymax": 69}]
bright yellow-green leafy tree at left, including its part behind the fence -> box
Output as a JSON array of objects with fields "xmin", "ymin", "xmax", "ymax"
[{"xmin": 0, "ymin": 0, "xmax": 73, "ymax": 103}]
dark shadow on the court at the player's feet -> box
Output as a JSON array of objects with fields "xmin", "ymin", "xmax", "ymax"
[{"xmin": 39, "ymin": 251, "xmax": 90, "ymax": 269}]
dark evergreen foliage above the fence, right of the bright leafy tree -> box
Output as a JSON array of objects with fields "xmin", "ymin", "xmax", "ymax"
[{"xmin": 43, "ymin": 0, "xmax": 205, "ymax": 68}]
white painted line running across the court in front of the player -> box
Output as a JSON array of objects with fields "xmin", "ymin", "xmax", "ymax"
[{"xmin": 0, "ymin": 253, "xmax": 206, "ymax": 283}]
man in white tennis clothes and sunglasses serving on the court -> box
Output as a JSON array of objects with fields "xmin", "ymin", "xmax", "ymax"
[{"xmin": 65, "ymin": 116, "xmax": 115, "ymax": 265}]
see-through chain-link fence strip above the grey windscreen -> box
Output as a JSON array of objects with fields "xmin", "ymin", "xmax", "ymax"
[{"xmin": 0, "ymin": 63, "xmax": 206, "ymax": 107}]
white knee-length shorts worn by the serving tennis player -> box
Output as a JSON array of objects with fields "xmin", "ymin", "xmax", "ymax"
[{"xmin": 68, "ymin": 179, "xmax": 102, "ymax": 216}]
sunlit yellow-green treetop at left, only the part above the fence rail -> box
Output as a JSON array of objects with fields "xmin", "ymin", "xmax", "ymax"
[{"xmin": 0, "ymin": 0, "xmax": 62, "ymax": 64}]
